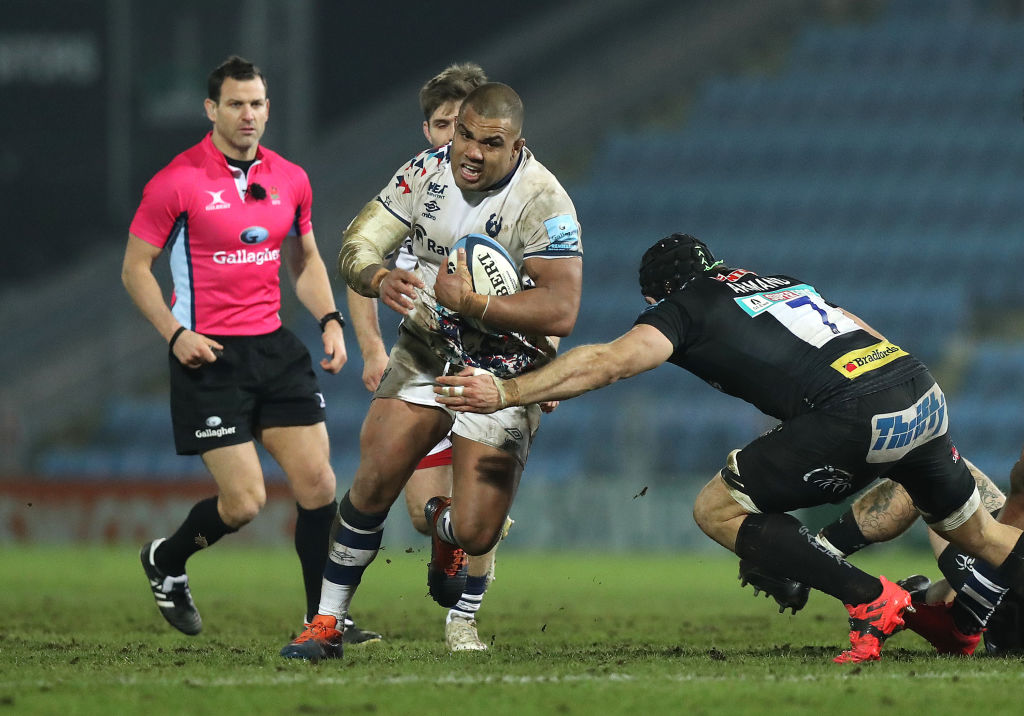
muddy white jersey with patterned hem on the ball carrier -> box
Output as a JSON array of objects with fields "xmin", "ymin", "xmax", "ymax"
[{"xmin": 377, "ymin": 144, "xmax": 583, "ymax": 378}]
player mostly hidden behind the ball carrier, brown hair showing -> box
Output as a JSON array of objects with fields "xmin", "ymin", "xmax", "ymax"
[{"xmin": 345, "ymin": 62, "xmax": 512, "ymax": 651}]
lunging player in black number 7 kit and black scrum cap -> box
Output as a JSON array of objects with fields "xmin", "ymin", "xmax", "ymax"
[{"xmin": 435, "ymin": 234, "xmax": 1024, "ymax": 663}]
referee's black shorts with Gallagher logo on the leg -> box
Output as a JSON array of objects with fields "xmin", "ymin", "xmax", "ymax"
[{"xmin": 170, "ymin": 327, "xmax": 325, "ymax": 455}]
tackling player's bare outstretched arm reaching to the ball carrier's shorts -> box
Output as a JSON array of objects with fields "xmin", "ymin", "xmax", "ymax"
[{"xmin": 434, "ymin": 324, "xmax": 675, "ymax": 413}]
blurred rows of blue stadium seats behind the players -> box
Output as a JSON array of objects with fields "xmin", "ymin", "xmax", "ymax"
[{"xmin": 29, "ymin": 0, "xmax": 1024, "ymax": 483}]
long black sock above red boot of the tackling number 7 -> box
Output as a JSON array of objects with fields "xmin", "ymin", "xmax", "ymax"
[{"xmin": 736, "ymin": 514, "xmax": 882, "ymax": 604}]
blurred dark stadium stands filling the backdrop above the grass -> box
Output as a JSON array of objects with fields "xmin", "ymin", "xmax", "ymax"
[{"xmin": 0, "ymin": 0, "xmax": 1024, "ymax": 549}]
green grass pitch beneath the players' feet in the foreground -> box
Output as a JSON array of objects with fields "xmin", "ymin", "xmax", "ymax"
[{"xmin": 0, "ymin": 544, "xmax": 1022, "ymax": 716}]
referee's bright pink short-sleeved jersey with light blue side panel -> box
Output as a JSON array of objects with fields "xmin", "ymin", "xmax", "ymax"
[{"xmin": 129, "ymin": 134, "xmax": 312, "ymax": 336}]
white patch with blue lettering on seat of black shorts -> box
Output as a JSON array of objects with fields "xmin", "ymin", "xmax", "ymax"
[{"xmin": 866, "ymin": 385, "xmax": 949, "ymax": 463}]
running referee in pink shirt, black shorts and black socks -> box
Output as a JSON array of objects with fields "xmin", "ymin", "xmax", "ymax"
[{"xmin": 121, "ymin": 56, "xmax": 377, "ymax": 636}]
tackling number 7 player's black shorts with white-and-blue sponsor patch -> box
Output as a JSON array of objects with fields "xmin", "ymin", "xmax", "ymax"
[{"xmin": 722, "ymin": 373, "xmax": 975, "ymax": 521}]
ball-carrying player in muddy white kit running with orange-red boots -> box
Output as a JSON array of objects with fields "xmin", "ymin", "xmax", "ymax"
[{"xmin": 281, "ymin": 83, "xmax": 583, "ymax": 661}]
